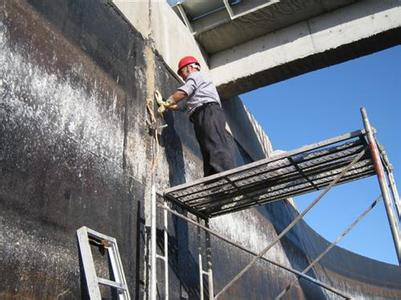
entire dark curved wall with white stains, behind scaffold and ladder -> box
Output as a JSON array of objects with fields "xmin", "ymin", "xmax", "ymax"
[{"xmin": 0, "ymin": 0, "xmax": 401, "ymax": 299}]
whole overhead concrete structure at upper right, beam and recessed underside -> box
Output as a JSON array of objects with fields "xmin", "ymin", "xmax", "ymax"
[{"xmin": 175, "ymin": 0, "xmax": 401, "ymax": 98}]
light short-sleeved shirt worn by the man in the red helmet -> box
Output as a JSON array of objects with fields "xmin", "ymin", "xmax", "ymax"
[{"xmin": 178, "ymin": 71, "xmax": 221, "ymax": 115}]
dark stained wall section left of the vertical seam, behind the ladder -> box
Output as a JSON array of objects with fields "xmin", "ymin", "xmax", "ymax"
[{"xmin": 0, "ymin": 0, "xmax": 146, "ymax": 299}]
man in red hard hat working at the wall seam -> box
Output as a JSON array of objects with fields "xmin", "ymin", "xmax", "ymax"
[{"xmin": 159, "ymin": 56, "xmax": 235, "ymax": 176}]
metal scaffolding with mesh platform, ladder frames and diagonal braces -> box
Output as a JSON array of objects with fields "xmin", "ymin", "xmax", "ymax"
[{"xmin": 149, "ymin": 108, "xmax": 401, "ymax": 300}]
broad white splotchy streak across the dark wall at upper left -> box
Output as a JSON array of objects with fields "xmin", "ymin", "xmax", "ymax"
[{"xmin": 0, "ymin": 22, "xmax": 124, "ymax": 171}]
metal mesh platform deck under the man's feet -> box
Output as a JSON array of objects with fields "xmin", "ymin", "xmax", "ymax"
[{"xmin": 164, "ymin": 130, "xmax": 375, "ymax": 218}]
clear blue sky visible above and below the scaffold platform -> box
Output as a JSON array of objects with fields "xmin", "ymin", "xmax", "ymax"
[{"xmin": 241, "ymin": 46, "xmax": 401, "ymax": 264}]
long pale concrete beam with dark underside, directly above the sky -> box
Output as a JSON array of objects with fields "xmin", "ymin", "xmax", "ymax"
[{"xmin": 209, "ymin": 0, "xmax": 401, "ymax": 98}]
